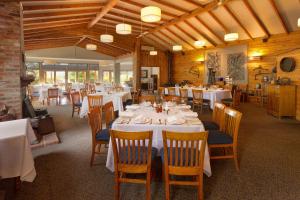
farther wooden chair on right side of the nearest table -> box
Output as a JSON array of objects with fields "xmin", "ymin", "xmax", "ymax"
[{"xmin": 202, "ymin": 102, "xmax": 226, "ymax": 130}]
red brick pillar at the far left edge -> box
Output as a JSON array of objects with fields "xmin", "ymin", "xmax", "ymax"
[{"xmin": 0, "ymin": 2, "xmax": 23, "ymax": 118}]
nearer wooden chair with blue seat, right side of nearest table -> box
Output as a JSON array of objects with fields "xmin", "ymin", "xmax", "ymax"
[{"xmin": 208, "ymin": 108, "xmax": 242, "ymax": 171}]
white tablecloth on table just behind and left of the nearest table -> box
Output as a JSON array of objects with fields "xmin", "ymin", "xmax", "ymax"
[{"xmin": 79, "ymin": 92, "xmax": 131, "ymax": 118}]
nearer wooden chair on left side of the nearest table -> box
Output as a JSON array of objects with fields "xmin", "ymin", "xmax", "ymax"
[{"xmin": 88, "ymin": 107, "xmax": 110, "ymax": 166}]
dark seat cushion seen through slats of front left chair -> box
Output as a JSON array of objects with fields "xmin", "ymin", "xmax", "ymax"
[{"xmin": 119, "ymin": 146, "xmax": 158, "ymax": 162}]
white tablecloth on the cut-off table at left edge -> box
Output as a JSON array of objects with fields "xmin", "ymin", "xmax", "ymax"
[{"xmin": 0, "ymin": 119, "xmax": 36, "ymax": 182}]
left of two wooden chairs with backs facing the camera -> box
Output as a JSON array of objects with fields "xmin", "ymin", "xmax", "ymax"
[{"xmin": 110, "ymin": 130, "xmax": 157, "ymax": 200}]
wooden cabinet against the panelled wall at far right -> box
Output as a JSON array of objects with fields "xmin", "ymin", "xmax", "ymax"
[{"xmin": 267, "ymin": 85, "xmax": 296, "ymax": 117}]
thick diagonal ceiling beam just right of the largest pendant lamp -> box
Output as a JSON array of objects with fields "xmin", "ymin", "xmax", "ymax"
[{"xmin": 144, "ymin": 0, "xmax": 232, "ymax": 35}]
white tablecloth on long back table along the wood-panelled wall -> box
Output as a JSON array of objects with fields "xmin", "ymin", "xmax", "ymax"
[{"xmin": 165, "ymin": 87, "xmax": 231, "ymax": 109}]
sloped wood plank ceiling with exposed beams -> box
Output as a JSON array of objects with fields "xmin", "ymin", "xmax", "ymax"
[{"xmin": 21, "ymin": 0, "xmax": 300, "ymax": 57}]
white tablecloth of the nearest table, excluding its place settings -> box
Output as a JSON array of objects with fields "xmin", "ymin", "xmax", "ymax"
[{"xmin": 106, "ymin": 107, "xmax": 212, "ymax": 176}]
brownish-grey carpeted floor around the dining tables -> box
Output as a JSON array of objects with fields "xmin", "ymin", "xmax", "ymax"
[{"xmin": 16, "ymin": 104, "xmax": 300, "ymax": 200}]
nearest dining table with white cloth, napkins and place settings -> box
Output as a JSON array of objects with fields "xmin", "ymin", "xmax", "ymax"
[{"xmin": 106, "ymin": 102, "xmax": 212, "ymax": 176}]
